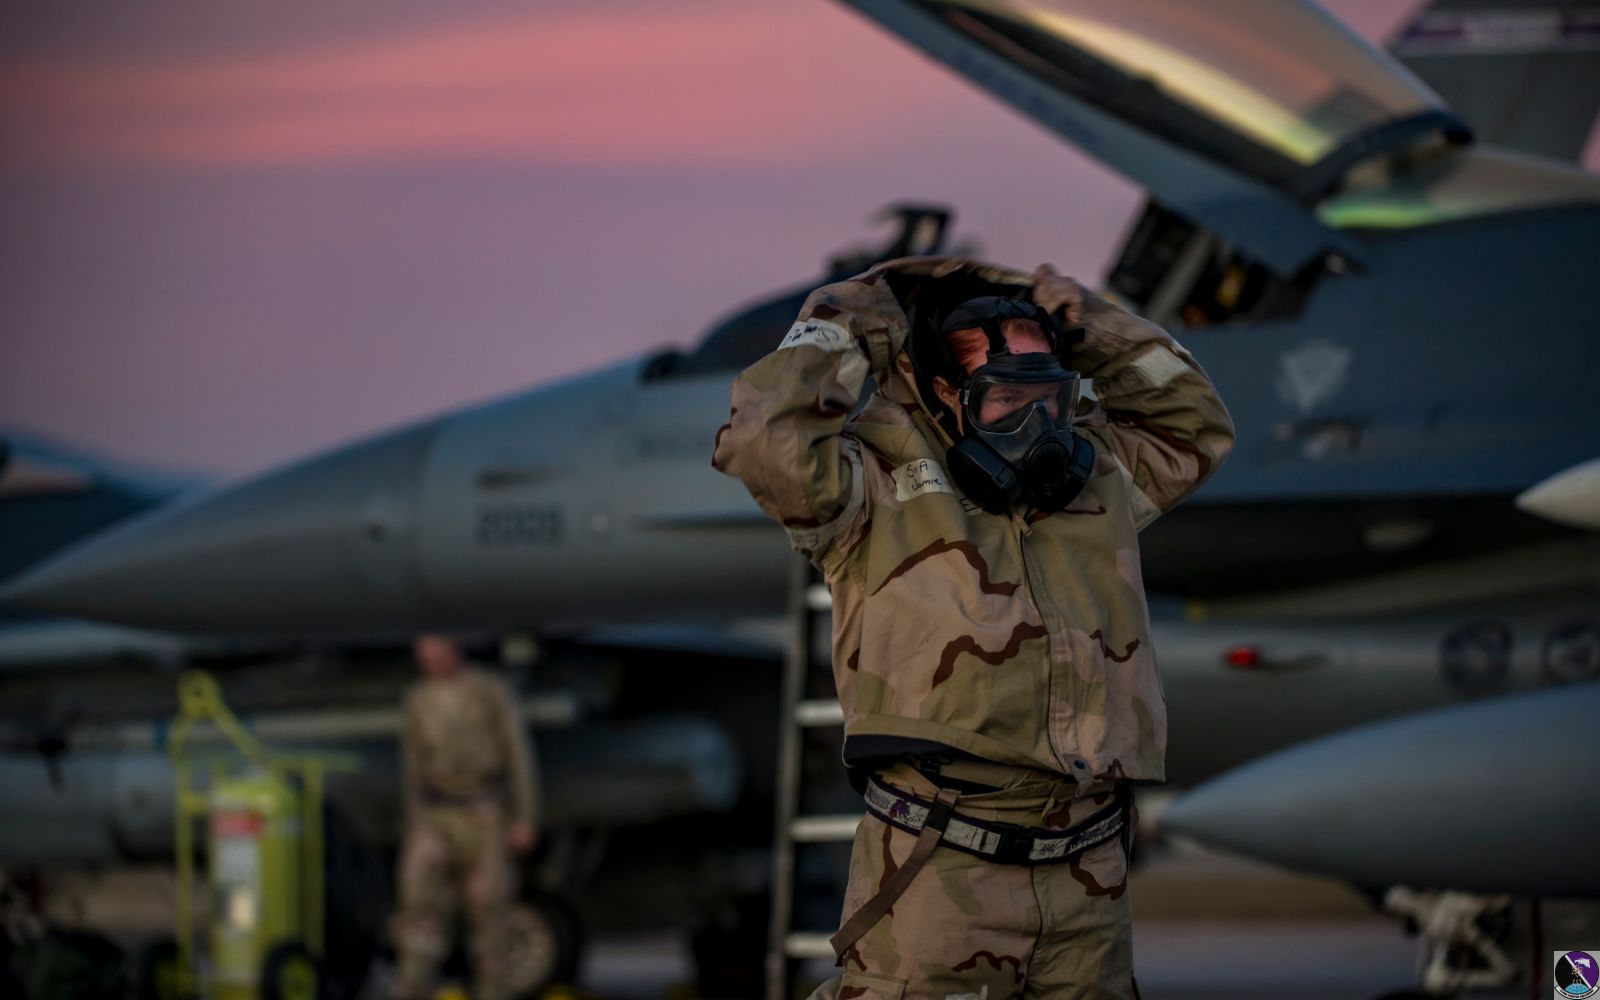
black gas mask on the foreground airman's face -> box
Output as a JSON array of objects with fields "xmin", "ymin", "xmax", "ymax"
[{"xmin": 941, "ymin": 296, "xmax": 1094, "ymax": 514}]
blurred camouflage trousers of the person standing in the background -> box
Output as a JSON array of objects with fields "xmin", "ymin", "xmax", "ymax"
[{"xmin": 390, "ymin": 802, "xmax": 517, "ymax": 1000}]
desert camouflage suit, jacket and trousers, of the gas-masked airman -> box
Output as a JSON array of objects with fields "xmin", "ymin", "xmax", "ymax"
[{"xmin": 712, "ymin": 258, "xmax": 1234, "ymax": 1000}]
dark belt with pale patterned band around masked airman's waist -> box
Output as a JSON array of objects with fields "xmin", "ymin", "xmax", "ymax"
[{"xmin": 866, "ymin": 778, "xmax": 1131, "ymax": 866}]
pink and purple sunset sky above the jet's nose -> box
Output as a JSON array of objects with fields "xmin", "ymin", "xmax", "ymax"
[{"xmin": 0, "ymin": 0, "xmax": 1536, "ymax": 475}]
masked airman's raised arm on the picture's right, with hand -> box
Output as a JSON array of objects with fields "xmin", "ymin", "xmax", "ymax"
[{"xmin": 1034, "ymin": 266, "xmax": 1234, "ymax": 530}]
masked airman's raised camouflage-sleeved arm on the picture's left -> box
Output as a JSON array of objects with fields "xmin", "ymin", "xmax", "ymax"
[{"xmin": 712, "ymin": 275, "xmax": 904, "ymax": 563}]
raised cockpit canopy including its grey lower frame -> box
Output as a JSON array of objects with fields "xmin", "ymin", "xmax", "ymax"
[{"xmin": 845, "ymin": 0, "xmax": 1467, "ymax": 277}]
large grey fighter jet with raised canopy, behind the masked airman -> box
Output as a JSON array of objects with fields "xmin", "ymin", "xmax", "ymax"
[{"xmin": 10, "ymin": 0, "xmax": 1600, "ymax": 617}]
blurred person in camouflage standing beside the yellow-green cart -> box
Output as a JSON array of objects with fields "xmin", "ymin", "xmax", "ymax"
[{"xmin": 392, "ymin": 635, "xmax": 538, "ymax": 1000}]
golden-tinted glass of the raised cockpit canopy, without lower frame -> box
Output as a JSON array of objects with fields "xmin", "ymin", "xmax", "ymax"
[{"xmin": 910, "ymin": 0, "xmax": 1446, "ymax": 195}]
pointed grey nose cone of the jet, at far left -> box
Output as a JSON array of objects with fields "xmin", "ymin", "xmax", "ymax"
[{"xmin": 0, "ymin": 422, "xmax": 437, "ymax": 634}]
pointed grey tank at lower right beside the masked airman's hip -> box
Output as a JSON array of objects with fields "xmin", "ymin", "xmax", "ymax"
[{"xmin": 1162, "ymin": 682, "xmax": 1600, "ymax": 896}]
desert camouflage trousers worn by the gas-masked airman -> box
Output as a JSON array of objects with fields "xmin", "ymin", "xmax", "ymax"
[{"xmin": 811, "ymin": 763, "xmax": 1138, "ymax": 1000}]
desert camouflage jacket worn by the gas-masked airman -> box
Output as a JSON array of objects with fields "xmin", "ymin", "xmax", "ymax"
[{"xmin": 712, "ymin": 258, "xmax": 1234, "ymax": 782}]
